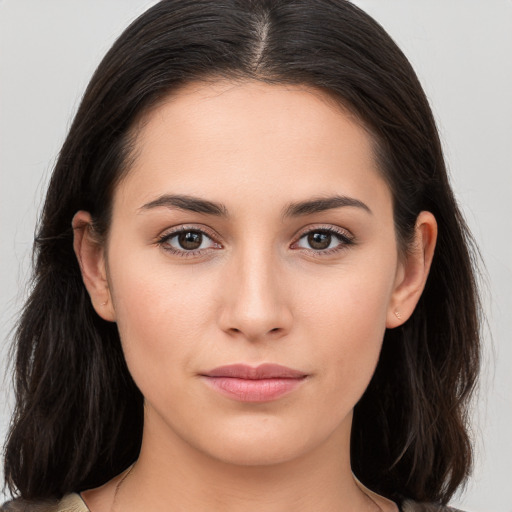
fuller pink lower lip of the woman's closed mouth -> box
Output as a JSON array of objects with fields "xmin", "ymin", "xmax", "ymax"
[{"xmin": 203, "ymin": 376, "xmax": 305, "ymax": 402}]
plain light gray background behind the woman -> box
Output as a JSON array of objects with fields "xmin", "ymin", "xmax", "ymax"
[{"xmin": 0, "ymin": 0, "xmax": 512, "ymax": 512}]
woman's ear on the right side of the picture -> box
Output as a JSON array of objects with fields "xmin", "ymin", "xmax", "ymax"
[{"xmin": 386, "ymin": 212, "xmax": 437, "ymax": 329}]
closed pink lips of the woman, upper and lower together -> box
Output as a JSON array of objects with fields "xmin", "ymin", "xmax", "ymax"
[{"xmin": 202, "ymin": 363, "xmax": 307, "ymax": 402}]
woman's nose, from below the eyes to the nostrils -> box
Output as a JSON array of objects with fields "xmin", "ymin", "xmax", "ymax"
[{"xmin": 218, "ymin": 246, "xmax": 293, "ymax": 341}]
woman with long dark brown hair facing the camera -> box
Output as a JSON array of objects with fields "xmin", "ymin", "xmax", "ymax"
[{"xmin": 4, "ymin": 0, "xmax": 479, "ymax": 512}]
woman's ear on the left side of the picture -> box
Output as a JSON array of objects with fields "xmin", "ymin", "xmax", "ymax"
[{"xmin": 72, "ymin": 210, "xmax": 116, "ymax": 322}]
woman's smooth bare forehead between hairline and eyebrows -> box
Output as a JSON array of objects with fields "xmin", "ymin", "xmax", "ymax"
[{"xmin": 115, "ymin": 81, "xmax": 387, "ymax": 214}]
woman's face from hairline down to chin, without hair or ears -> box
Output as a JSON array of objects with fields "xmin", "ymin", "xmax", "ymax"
[{"xmin": 87, "ymin": 82, "xmax": 412, "ymax": 465}]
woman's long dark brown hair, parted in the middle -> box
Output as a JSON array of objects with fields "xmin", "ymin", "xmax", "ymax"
[{"xmin": 5, "ymin": 0, "xmax": 480, "ymax": 503}]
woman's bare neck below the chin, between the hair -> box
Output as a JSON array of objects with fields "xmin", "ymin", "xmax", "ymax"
[{"xmin": 114, "ymin": 406, "xmax": 379, "ymax": 512}]
